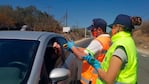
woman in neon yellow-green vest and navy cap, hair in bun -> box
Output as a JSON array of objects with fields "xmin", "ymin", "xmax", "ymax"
[{"xmin": 67, "ymin": 14, "xmax": 142, "ymax": 84}]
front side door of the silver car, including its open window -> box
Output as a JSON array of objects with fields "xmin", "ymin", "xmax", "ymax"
[{"xmin": 40, "ymin": 37, "xmax": 80, "ymax": 84}]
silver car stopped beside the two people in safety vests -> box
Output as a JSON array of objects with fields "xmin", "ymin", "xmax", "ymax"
[{"xmin": 0, "ymin": 31, "xmax": 81, "ymax": 84}]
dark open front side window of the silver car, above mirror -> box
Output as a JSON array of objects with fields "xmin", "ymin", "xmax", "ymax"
[{"xmin": 39, "ymin": 37, "xmax": 67, "ymax": 84}]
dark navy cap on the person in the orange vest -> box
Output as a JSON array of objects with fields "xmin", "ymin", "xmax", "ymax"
[{"xmin": 87, "ymin": 18, "xmax": 107, "ymax": 32}]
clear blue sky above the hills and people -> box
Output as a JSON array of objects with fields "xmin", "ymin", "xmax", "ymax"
[{"xmin": 0, "ymin": 0, "xmax": 149, "ymax": 28}]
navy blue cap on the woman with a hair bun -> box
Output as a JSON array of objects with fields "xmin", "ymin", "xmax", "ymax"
[{"xmin": 108, "ymin": 14, "xmax": 134, "ymax": 29}]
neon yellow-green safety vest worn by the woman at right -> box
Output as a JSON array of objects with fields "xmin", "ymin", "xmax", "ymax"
[{"xmin": 96, "ymin": 31, "xmax": 138, "ymax": 84}]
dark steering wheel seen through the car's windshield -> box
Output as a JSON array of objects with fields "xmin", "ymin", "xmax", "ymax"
[{"xmin": 8, "ymin": 61, "xmax": 27, "ymax": 70}]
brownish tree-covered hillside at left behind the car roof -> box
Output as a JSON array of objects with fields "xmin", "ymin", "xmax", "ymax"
[{"xmin": 0, "ymin": 6, "xmax": 62, "ymax": 32}]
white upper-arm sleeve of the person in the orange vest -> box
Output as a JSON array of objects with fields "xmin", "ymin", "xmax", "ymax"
[{"xmin": 85, "ymin": 40, "xmax": 103, "ymax": 54}]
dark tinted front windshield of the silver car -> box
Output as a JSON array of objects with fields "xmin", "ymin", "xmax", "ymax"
[{"xmin": 0, "ymin": 39, "xmax": 39, "ymax": 84}]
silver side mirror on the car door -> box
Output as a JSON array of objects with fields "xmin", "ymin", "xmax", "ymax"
[{"xmin": 49, "ymin": 68, "xmax": 70, "ymax": 84}]
